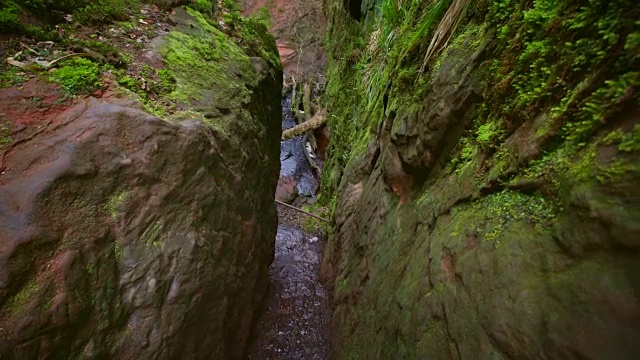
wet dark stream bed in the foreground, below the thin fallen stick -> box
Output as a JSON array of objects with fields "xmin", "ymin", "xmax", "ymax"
[{"xmin": 249, "ymin": 225, "xmax": 330, "ymax": 360}]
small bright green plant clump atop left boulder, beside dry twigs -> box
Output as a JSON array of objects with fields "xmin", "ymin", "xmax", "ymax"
[{"xmin": 49, "ymin": 58, "xmax": 101, "ymax": 95}]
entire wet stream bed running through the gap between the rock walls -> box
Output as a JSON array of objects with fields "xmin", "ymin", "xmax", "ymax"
[{"xmin": 248, "ymin": 96, "xmax": 331, "ymax": 360}]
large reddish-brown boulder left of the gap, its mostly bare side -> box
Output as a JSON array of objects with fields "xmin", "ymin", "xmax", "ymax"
[{"xmin": 0, "ymin": 5, "xmax": 281, "ymax": 359}]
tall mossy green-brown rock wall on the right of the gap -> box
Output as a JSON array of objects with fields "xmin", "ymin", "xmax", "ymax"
[{"xmin": 323, "ymin": 1, "xmax": 640, "ymax": 359}]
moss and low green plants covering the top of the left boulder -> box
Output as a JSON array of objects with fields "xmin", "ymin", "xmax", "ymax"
[{"xmin": 0, "ymin": 0, "xmax": 280, "ymax": 117}]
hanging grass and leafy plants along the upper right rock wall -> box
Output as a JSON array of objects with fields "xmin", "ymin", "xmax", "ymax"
[{"xmin": 323, "ymin": 0, "xmax": 640, "ymax": 208}]
